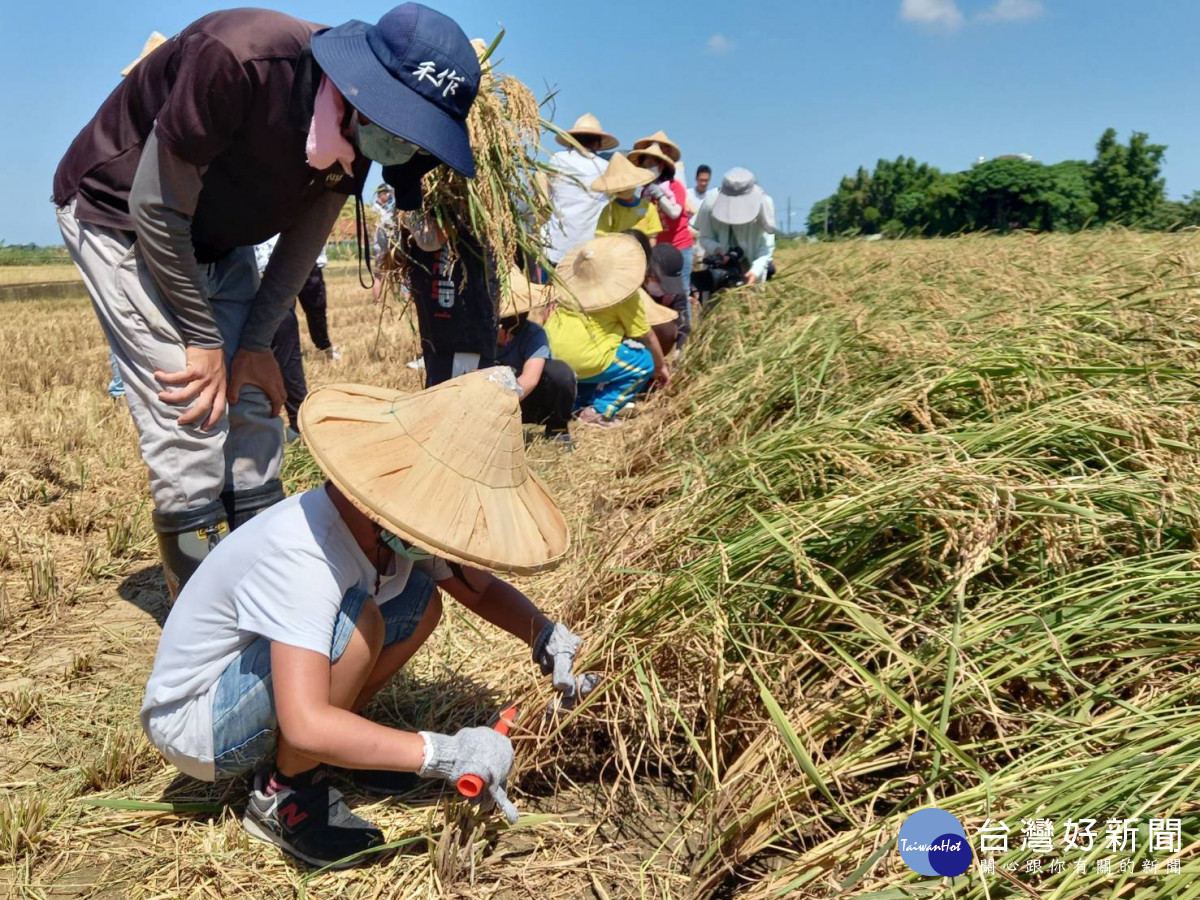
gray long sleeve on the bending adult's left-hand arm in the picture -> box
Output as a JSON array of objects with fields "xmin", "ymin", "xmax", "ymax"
[{"xmin": 130, "ymin": 131, "xmax": 223, "ymax": 348}]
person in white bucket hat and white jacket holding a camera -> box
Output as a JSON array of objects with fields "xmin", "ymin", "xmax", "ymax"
[{"xmin": 696, "ymin": 168, "xmax": 775, "ymax": 284}]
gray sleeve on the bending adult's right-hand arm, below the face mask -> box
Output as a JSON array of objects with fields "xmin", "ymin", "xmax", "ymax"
[{"xmin": 238, "ymin": 191, "xmax": 347, "ymax": 353}]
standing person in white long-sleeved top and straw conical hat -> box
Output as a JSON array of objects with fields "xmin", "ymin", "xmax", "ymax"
[{"xmin": 546, "ymin": 113, "xmax": 618, "ymax": 265}]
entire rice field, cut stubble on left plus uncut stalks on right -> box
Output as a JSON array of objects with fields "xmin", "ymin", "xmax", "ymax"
[{"xmin": 0, "ymin": 230, "xmax": 1200, "ymax": 900}]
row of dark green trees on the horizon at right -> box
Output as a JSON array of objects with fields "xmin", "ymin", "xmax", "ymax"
[{"xmin": 808, "ymin": 128, "xmax": 1200, "ymax": 236}]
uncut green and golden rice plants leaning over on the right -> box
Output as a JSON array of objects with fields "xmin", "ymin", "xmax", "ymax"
[{"xmin": 518, "ymin": 234, "xmax": 1200, "ymax": 898}]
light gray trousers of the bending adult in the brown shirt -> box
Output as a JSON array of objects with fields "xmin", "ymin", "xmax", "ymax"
[{"xmin": 58, "ymin": 203, "xmax": 283, "ymax": 512}]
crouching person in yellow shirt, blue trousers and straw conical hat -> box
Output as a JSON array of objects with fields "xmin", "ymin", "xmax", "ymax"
[{"xmin": 546, "ymin": 234, "xmax": 671, "ymax": 425}]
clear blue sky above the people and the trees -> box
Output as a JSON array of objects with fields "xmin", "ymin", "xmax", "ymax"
[{"xmin": 0, "ymin": 0, "xmax": 1200, "ymax": 244}]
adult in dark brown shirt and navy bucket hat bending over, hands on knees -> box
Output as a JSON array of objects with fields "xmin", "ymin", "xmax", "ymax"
[{"xmin": 54, "ymin": 4, "xmax": 480, "ymax": 602}]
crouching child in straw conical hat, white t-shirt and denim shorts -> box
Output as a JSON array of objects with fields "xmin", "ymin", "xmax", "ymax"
[{"xmin": 142, "ymin": 367, "xmax": 593, "ymax": 866}]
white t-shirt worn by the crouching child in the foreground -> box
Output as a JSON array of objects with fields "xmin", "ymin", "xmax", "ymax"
[{"xmin": 142, "ymin": 487, "xmax": 450, "ymax": 781}]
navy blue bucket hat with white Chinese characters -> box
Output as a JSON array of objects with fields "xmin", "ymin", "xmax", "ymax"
[{"xmin": 312, "ymin": 4, "xmax": 480, "ymax": 178}]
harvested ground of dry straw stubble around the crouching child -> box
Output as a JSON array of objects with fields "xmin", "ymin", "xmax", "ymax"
[{"xmin": 0, "ymin": 268, "xmax": 668, "ymax": 898}]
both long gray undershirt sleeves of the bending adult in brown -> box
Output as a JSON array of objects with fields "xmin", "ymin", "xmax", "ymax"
[{"xmin": 130, "ymin": 131, "xmax": 346, "ymax": 352}]
